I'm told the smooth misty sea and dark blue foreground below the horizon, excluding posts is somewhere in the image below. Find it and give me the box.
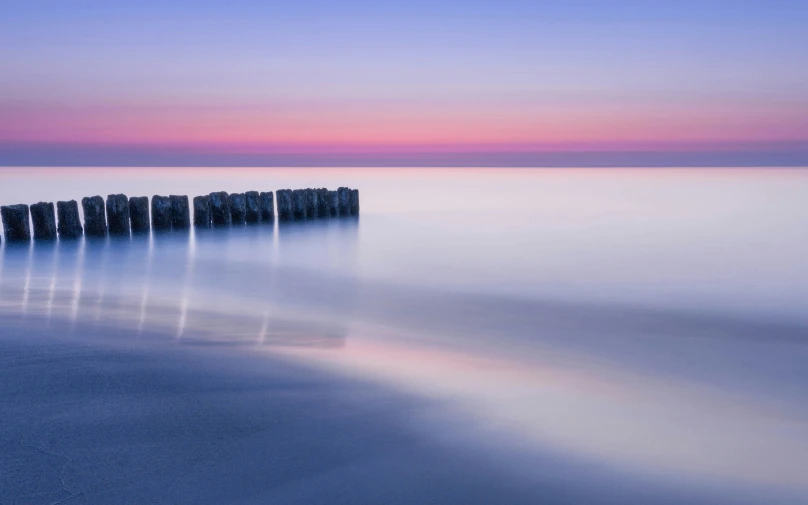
[0,168,808,504]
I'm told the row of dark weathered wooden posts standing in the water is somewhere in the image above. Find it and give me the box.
[0,187,359,242]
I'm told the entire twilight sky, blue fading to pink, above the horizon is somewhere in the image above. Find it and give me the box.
[0,0,808,166]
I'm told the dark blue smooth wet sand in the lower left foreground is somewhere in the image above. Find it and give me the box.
[0,319,804,505]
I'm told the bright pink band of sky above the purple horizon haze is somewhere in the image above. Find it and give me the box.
[0,102,808,152]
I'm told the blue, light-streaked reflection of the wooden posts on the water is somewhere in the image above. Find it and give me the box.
[0,223,356,347]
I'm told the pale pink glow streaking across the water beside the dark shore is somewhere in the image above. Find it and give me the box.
[272,328,808,492]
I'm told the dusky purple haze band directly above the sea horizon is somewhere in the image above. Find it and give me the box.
[0,140,808,168]
